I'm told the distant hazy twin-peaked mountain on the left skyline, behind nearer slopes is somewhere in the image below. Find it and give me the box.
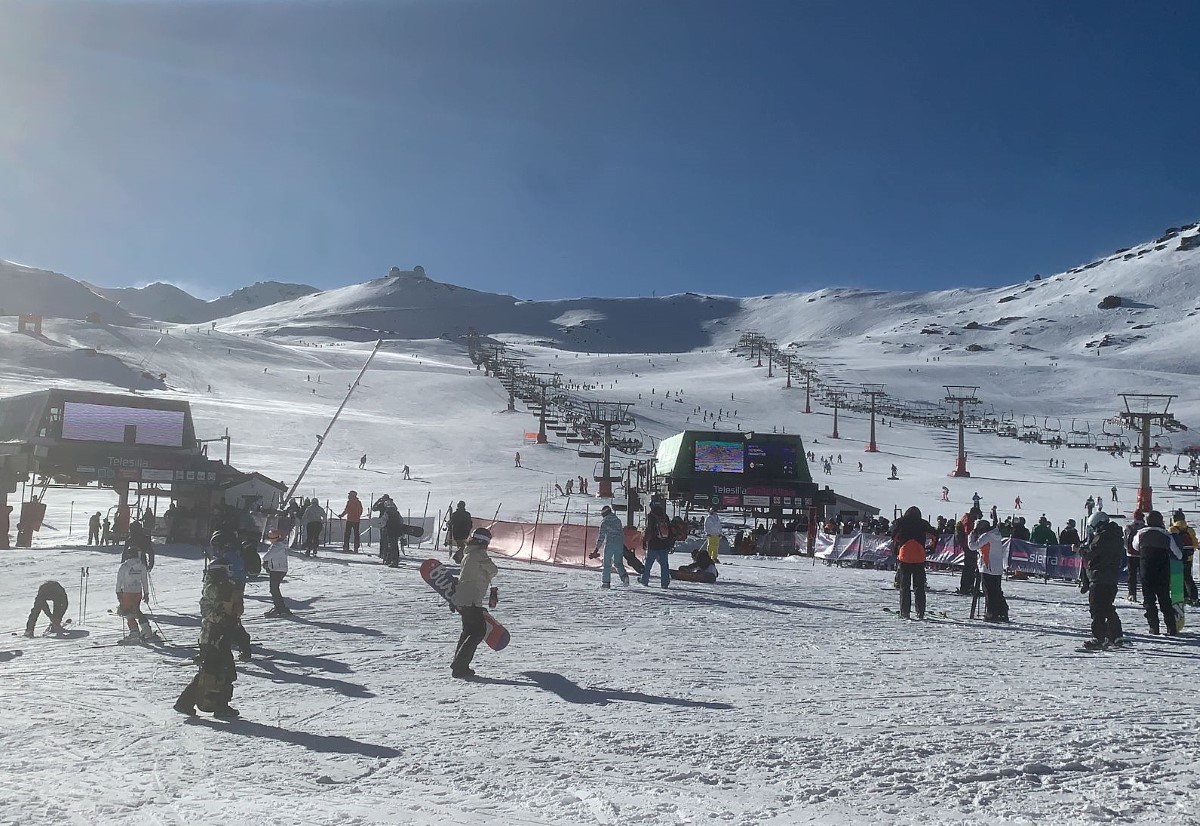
[86,281,317,324]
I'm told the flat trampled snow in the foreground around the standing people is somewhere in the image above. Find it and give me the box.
[0,537,1200,825]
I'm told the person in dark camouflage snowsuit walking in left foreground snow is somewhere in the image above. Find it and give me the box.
[174,558,242,718]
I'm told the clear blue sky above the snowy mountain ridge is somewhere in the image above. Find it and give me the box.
[0,0,1200,298]
